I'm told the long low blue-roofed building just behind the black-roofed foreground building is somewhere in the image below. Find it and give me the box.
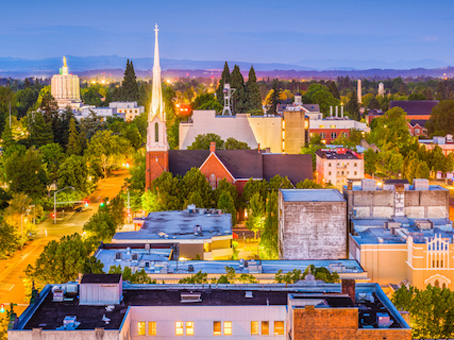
[94,243,369,283]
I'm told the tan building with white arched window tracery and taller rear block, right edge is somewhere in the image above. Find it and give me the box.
[344,179,454,289]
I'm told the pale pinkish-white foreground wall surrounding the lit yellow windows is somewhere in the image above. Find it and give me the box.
[127,301,287,340]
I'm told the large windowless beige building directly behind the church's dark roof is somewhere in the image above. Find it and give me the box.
[180,110,309,154]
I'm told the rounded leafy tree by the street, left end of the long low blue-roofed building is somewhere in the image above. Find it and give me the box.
[27,234,93,283]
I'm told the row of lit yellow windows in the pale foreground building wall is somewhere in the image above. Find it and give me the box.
[137,321,284,336]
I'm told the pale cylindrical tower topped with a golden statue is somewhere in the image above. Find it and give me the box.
[51,57,82,110]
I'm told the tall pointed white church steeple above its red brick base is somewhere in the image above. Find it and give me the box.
[147,24,169,152]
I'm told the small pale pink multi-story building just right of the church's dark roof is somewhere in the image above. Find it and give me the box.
[315,148,364,187]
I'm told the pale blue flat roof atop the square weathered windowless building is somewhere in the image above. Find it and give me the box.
[280,189,345,202]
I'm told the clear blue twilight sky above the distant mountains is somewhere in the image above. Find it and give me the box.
[0,0,454,65]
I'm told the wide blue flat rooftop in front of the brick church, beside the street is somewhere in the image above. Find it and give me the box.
[113,209,232,242]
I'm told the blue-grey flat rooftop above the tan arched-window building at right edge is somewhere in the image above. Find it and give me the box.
[352,218,454,244]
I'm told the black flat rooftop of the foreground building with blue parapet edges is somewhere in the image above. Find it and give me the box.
[13,282,408,331]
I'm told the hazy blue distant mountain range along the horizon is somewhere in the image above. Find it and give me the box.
[0,55,454,79]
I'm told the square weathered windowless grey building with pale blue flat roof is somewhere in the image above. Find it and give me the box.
[278,189,347,260]
